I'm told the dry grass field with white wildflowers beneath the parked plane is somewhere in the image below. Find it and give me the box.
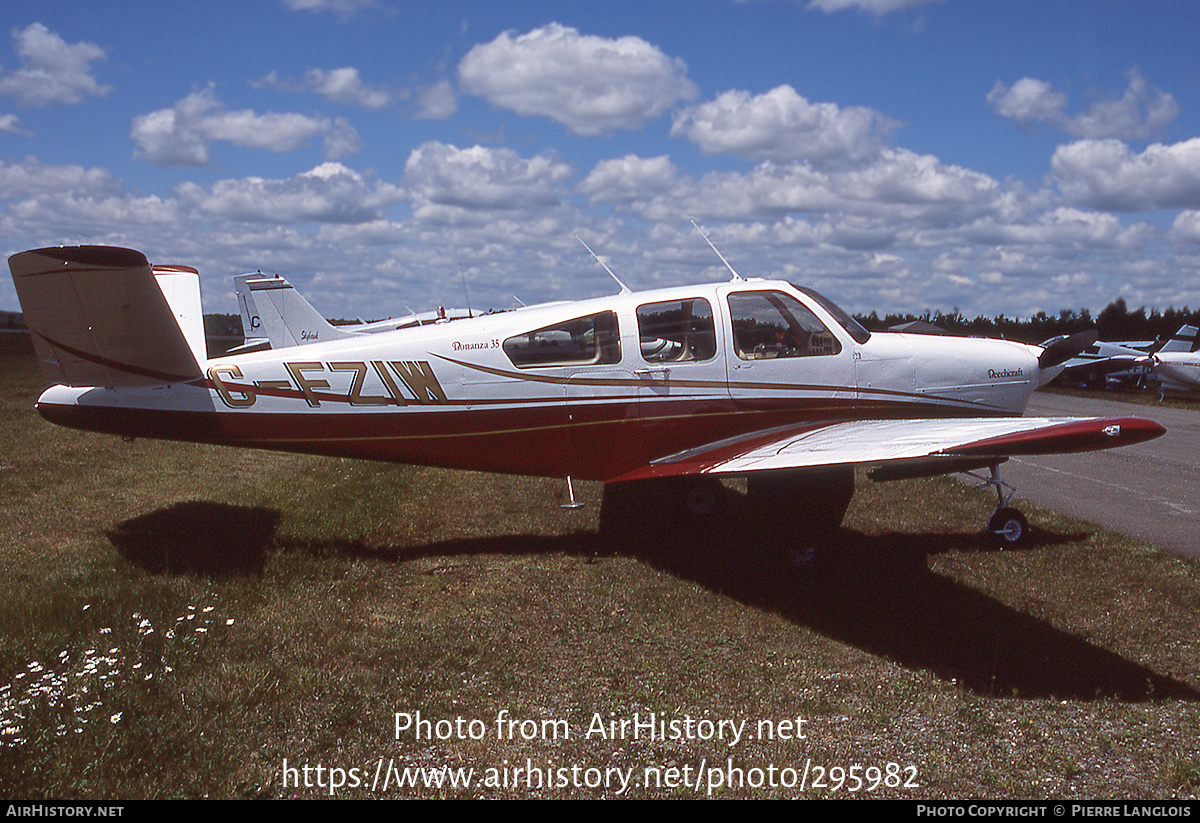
[0,336,1200,799]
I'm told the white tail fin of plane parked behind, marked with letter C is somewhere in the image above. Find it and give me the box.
[233,274,353,350]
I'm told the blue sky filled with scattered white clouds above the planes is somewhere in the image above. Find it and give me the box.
[0,0,1200,319]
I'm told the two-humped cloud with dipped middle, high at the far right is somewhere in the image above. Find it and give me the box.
[988,70,1180,139]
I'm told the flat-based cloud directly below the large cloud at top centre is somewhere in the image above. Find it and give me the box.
[404,143,572,214]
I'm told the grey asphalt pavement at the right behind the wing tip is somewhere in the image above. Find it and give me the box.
[1001,392,1200,557]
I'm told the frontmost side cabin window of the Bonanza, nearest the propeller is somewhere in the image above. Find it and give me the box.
[728,292,841,360]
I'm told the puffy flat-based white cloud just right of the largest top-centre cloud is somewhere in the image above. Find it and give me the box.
[671,85,899,162]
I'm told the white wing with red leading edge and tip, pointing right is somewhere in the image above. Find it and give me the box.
[612,417,1166,481]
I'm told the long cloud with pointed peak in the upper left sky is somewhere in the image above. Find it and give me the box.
[130,84,361,166]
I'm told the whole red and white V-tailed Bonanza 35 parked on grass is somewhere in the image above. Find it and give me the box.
[8,246,1164,551]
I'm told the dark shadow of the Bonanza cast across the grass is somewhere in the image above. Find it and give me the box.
[108,501,1200,702]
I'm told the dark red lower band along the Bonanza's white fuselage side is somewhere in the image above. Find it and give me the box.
[38,398,902,480]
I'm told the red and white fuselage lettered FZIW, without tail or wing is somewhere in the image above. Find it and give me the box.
[38,281,1044,480]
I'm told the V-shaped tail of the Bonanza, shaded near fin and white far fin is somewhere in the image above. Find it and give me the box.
[8,246,205,388]
